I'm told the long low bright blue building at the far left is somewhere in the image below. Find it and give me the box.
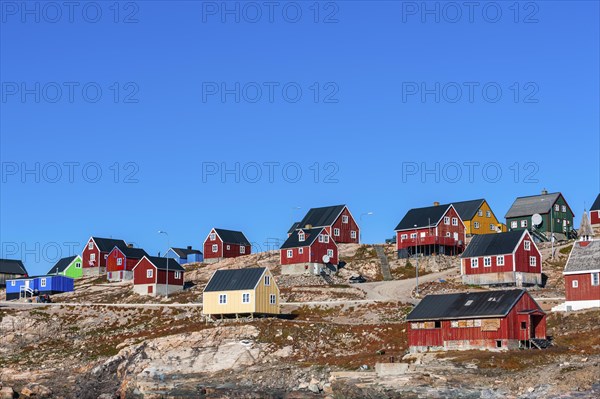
[6,275,75,301]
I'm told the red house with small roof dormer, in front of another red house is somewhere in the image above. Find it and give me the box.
[279,227,338,274]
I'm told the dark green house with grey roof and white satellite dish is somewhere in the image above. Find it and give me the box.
[505,190,575,241]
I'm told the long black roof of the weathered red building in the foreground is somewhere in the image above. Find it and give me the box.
[406,290,526,321]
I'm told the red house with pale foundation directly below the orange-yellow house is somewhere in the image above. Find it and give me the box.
[460,230,542,287]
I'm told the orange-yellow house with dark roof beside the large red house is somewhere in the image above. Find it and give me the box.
[452,198,506,236]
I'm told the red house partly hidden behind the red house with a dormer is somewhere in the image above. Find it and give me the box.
[288,205,360,244]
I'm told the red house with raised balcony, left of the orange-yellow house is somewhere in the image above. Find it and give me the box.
[395,202,466,259]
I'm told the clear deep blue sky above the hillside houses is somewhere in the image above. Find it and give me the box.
[0,1,600,274]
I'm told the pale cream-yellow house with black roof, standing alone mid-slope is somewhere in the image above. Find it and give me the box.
[202,267,280,316]
